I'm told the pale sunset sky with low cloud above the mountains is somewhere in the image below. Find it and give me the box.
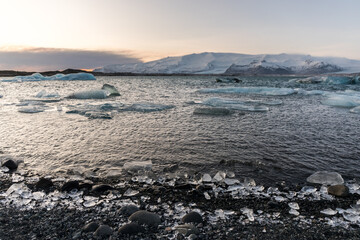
[0,0,360,71]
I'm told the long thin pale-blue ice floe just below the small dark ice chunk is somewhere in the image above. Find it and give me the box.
[198,87,295,96]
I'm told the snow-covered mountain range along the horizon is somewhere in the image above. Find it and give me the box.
[94,53,360,75]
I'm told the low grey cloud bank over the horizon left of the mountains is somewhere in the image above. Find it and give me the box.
[0,48,141,71]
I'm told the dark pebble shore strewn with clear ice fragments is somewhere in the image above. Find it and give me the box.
[0,168,360,240]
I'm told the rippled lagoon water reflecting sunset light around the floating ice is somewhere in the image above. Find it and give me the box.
[0,77,360,185]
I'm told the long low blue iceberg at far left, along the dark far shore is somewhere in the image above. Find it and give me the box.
[1,73,96,82]
